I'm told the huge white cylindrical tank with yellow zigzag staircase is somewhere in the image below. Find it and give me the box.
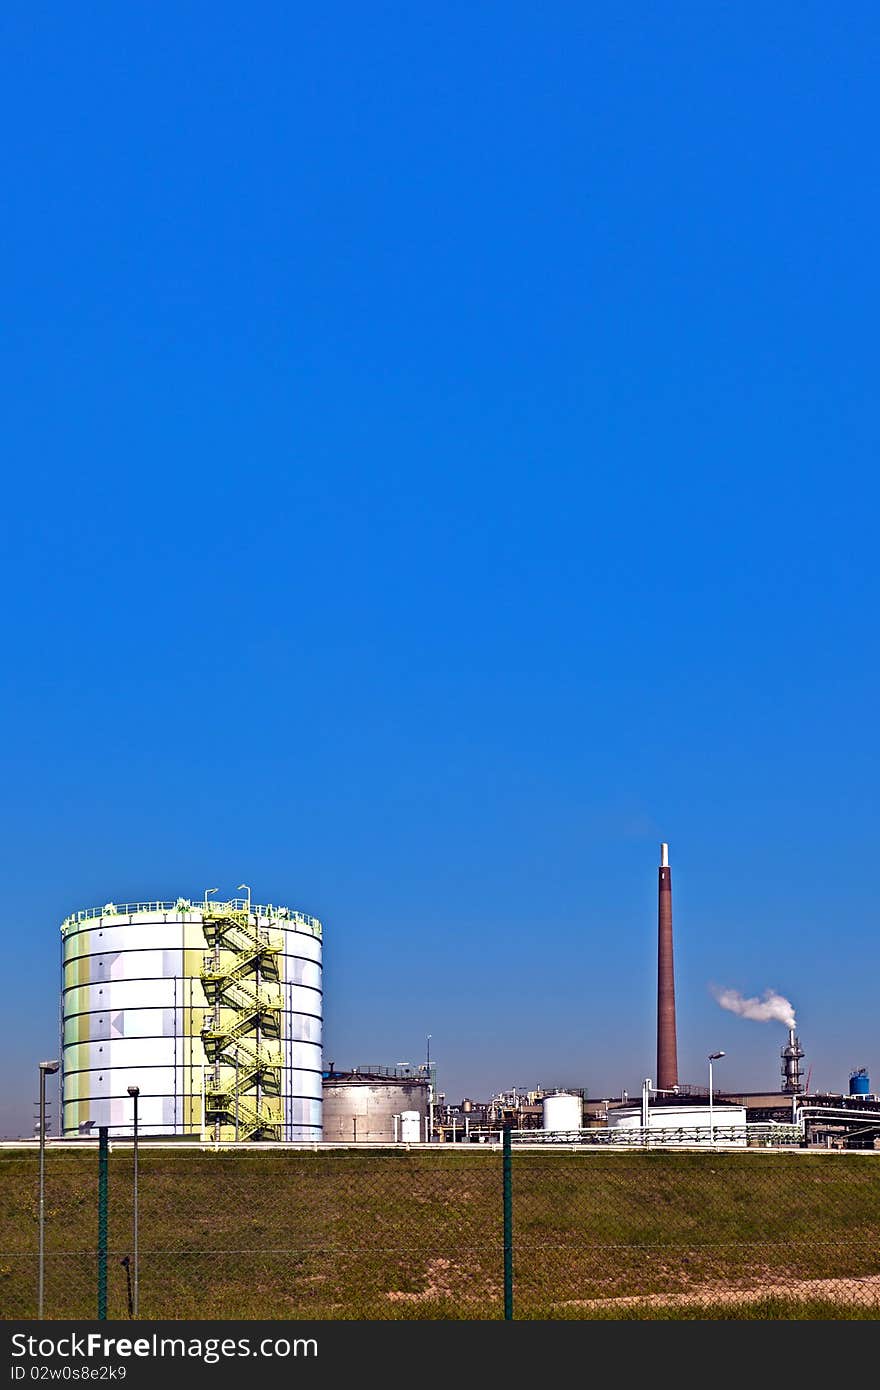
[61,898,323,1141]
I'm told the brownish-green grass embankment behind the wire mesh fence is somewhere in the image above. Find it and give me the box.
[0,1145,880,1319]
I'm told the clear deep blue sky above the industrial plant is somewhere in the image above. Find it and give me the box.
[0,0,880,1134]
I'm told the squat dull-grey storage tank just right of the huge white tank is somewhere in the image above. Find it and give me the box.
[324,1063,430,1144]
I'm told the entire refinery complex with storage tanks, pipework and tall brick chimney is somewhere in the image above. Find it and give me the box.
[61,844,880,1148]
